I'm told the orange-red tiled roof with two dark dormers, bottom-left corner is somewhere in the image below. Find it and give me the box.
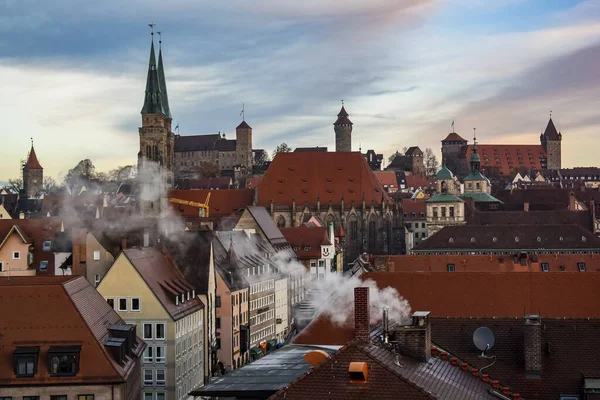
[0,276,145,386]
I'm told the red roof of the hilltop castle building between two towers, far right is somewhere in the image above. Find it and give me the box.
[467,143,546,175]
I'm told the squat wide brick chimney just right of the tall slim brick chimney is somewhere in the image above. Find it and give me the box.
[391,311,431,361]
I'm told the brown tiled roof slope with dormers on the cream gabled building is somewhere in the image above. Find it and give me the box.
[122,247,204,321]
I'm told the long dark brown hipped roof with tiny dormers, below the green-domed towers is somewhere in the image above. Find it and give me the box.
[413,224,600,253]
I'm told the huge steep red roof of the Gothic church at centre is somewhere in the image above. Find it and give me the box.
[258,152,391,207]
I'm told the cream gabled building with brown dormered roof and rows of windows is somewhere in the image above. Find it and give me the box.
[98,247,204,400]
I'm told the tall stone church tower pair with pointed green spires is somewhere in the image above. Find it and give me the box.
[138,32,175,216]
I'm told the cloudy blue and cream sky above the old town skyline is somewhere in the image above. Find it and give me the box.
[0,0,600,180]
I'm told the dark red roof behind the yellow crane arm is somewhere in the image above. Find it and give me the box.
[169,189,254,217]
